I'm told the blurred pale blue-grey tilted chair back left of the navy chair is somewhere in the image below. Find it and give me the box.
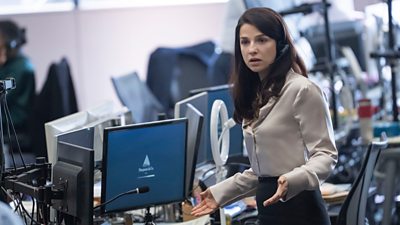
[111,72,164,123]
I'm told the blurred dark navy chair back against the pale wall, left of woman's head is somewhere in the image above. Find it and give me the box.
[146,41,233,117]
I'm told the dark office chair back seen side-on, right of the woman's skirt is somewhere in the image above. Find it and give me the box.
[336,133,387,225]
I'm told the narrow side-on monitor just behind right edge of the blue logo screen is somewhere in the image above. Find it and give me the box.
[185,103,204,197]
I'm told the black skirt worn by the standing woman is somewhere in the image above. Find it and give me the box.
[256,177,331,225]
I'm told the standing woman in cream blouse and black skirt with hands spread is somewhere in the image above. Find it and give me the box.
[192,8,337,225]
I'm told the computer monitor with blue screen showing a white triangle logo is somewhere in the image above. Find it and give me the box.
[101,118,187,213]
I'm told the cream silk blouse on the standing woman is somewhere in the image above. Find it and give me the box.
[210,71,338,206]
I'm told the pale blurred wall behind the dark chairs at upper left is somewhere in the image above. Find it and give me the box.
[0,3,225,109]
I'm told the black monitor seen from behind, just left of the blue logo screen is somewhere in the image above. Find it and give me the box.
[52,141,94,225]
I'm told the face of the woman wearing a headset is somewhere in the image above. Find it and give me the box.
[239,23,276,80]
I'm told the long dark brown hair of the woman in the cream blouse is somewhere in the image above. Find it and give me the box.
[231,8,307,123]
